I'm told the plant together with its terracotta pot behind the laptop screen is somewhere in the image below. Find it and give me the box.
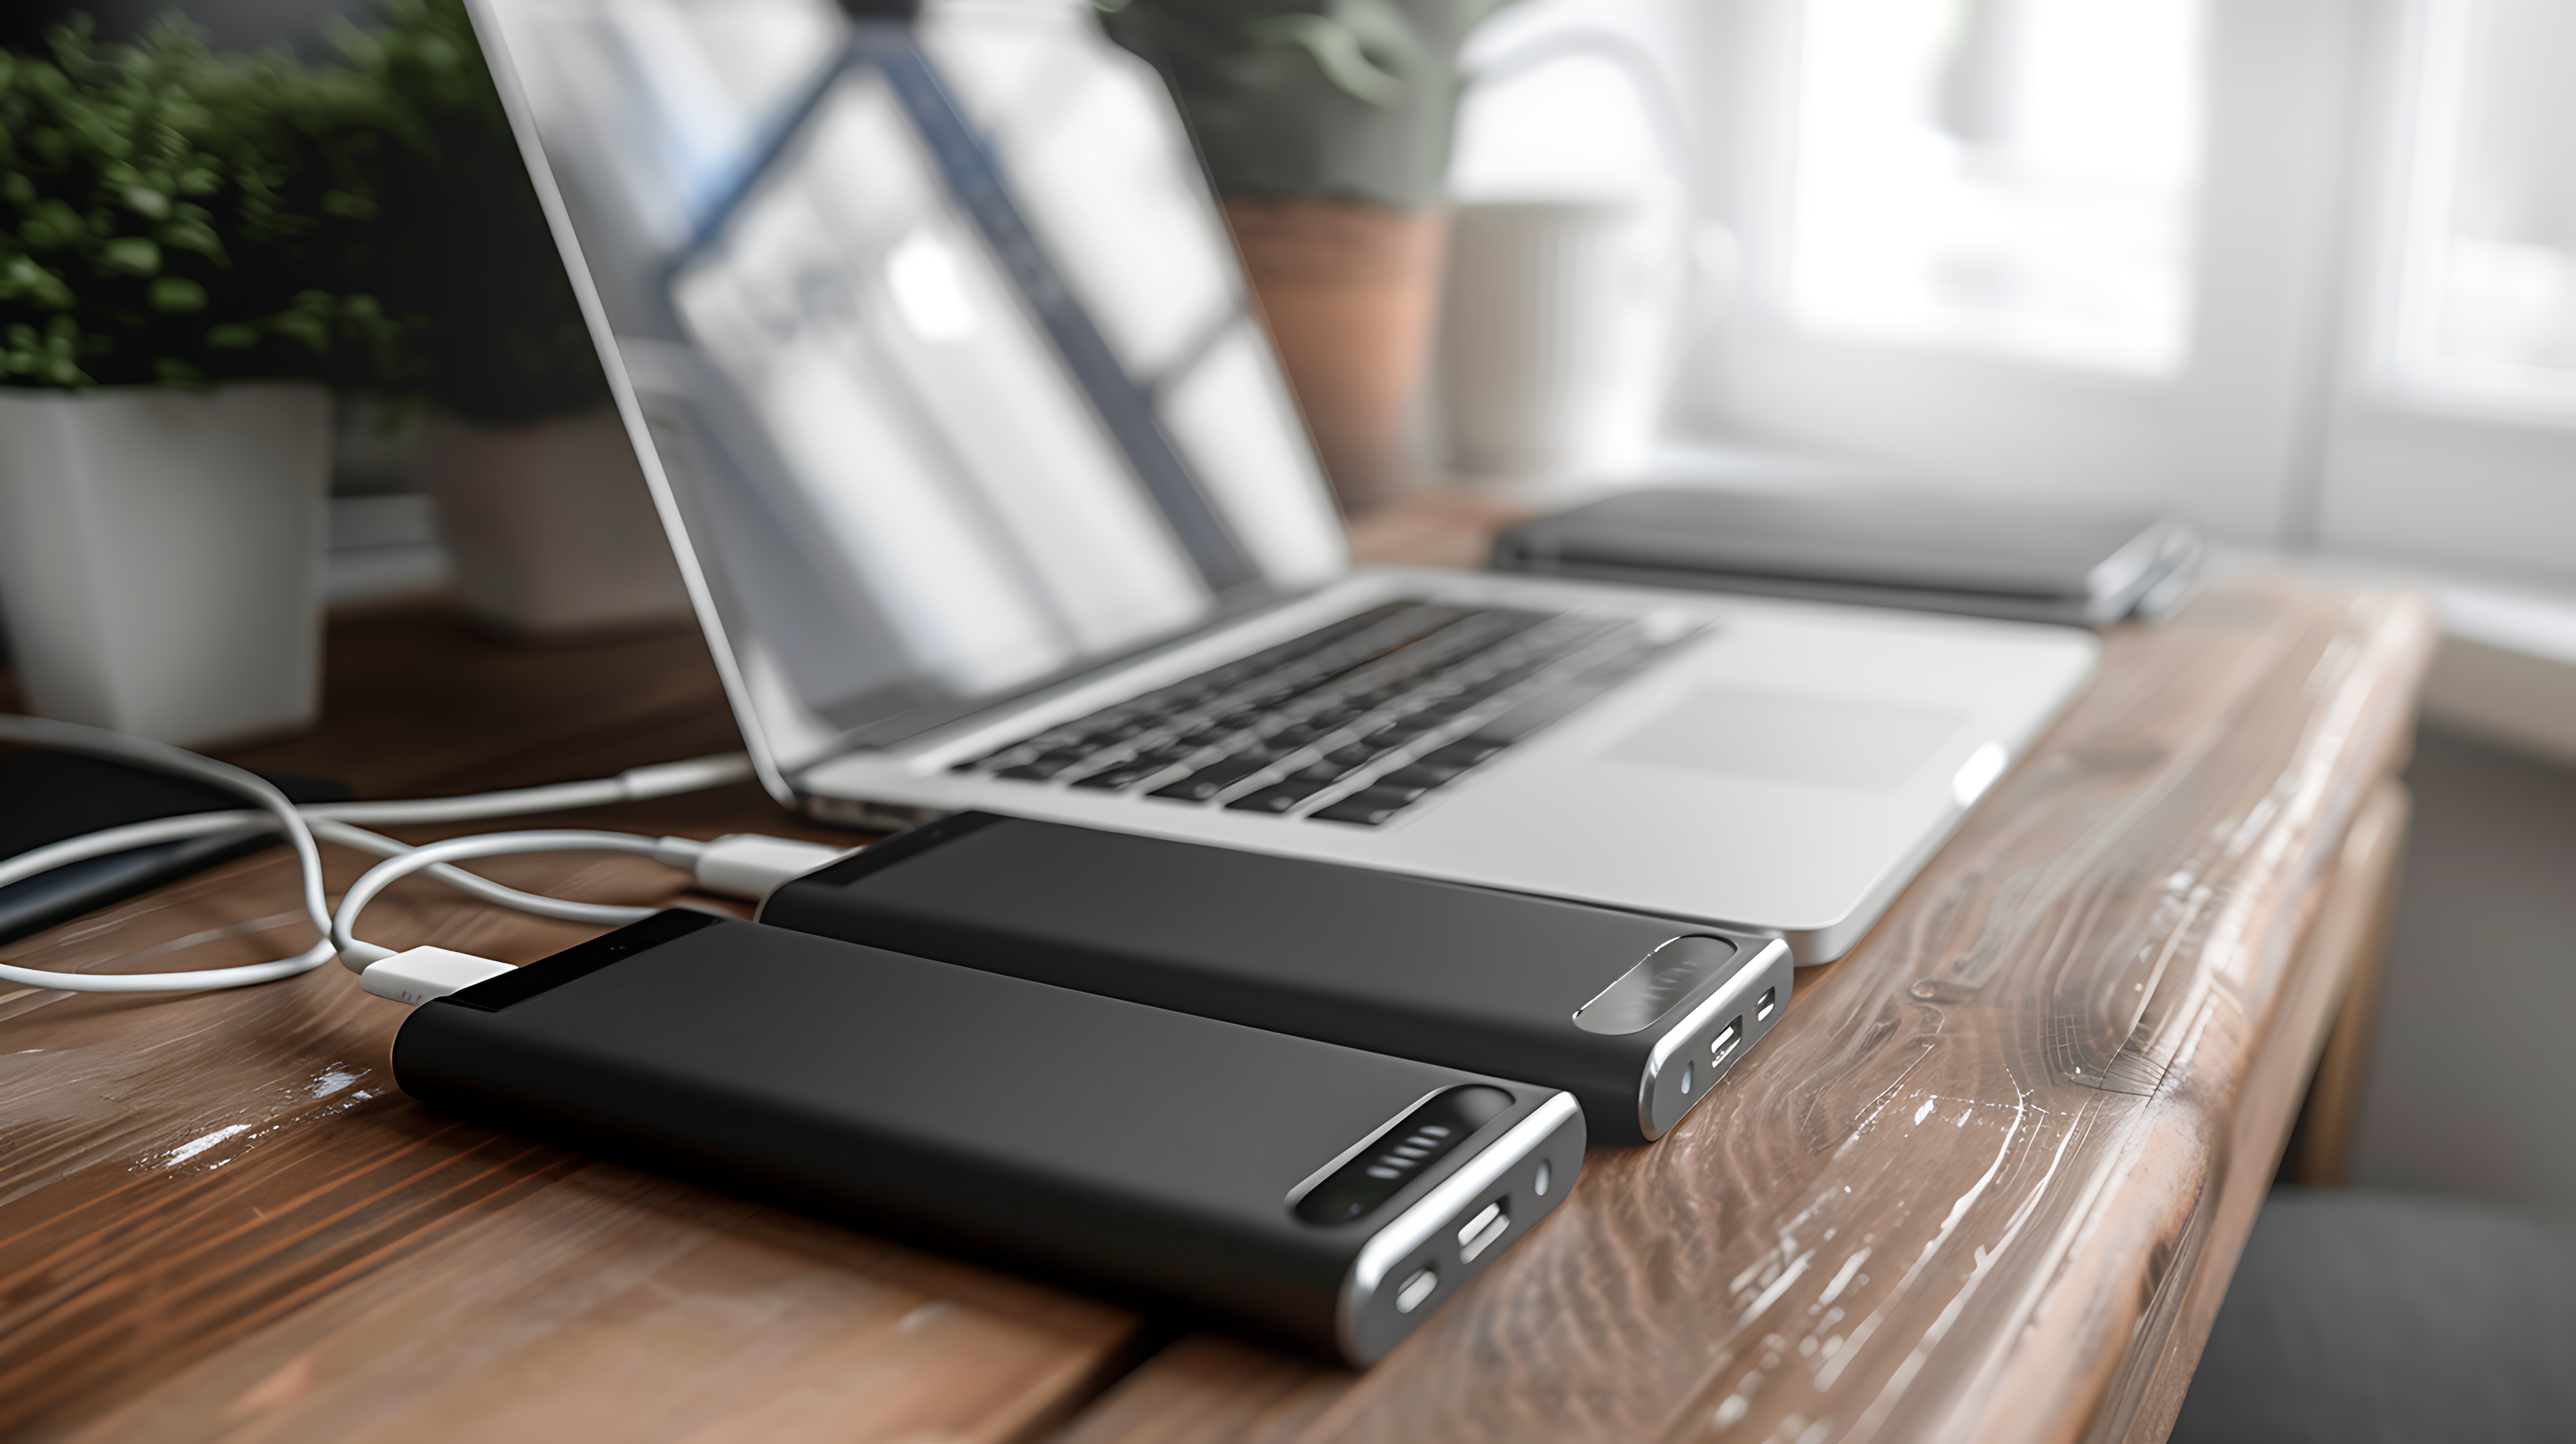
[1097,0,1507,511]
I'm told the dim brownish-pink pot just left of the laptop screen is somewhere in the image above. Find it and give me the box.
[420,407,688,637]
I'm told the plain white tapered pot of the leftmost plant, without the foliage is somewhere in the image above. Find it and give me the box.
[0,382,330,745]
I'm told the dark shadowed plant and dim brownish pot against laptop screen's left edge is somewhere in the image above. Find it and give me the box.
[340,0,688,637]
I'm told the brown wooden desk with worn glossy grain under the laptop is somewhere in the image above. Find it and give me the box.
[0,513,2432,1444]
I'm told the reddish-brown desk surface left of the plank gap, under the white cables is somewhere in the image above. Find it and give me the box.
[0,609,1136,1441]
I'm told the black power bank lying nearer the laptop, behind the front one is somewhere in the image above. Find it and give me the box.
[760,812,1793,1142]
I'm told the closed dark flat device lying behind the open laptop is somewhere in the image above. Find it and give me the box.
[1489,490,2200,626]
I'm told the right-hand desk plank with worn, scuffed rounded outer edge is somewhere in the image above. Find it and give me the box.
[1064,583,2432,1444]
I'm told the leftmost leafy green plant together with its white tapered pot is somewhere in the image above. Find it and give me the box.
[0,23,399,743]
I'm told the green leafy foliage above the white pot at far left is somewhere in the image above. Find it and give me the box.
[0,21,404,387]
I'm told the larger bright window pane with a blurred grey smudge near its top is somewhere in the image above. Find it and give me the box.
[1788,0,2203,376]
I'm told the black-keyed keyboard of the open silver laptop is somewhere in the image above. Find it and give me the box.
[951,601,1675,828]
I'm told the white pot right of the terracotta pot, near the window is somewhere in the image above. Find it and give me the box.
[1440,199,1687,477]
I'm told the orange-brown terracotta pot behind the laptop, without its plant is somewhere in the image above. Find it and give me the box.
[1226,196,1448,516]
